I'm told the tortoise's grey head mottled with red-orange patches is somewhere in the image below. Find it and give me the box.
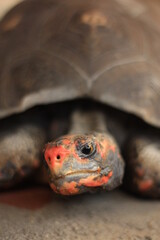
[44,133,124,195]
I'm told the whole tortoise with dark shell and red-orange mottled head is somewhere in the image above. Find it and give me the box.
[0,0,160,198]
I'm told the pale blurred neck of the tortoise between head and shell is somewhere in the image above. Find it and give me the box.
[69,110,107,134]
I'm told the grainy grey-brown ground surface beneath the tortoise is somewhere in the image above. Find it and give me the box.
[0,189,160,240]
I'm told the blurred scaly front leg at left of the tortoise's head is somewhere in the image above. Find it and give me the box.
[0,119,46,188]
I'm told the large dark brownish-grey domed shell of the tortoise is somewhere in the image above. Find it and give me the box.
[0,0,160,126]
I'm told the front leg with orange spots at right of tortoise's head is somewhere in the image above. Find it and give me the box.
[124,133,160,198]
